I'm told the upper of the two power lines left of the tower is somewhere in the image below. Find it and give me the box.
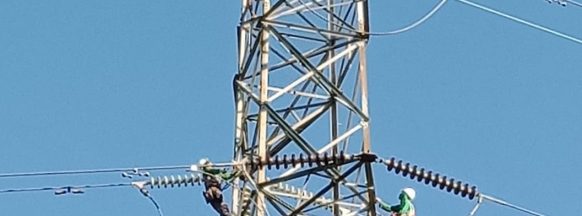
[0,165,190,178]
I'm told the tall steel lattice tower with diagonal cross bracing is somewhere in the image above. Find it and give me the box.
[232,0,376,216]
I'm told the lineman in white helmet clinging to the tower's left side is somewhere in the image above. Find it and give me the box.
[199,158,238,216]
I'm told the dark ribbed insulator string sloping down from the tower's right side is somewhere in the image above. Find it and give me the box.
[380,157,479,200]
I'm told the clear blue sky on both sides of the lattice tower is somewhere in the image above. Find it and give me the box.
[0,0,582,216]
